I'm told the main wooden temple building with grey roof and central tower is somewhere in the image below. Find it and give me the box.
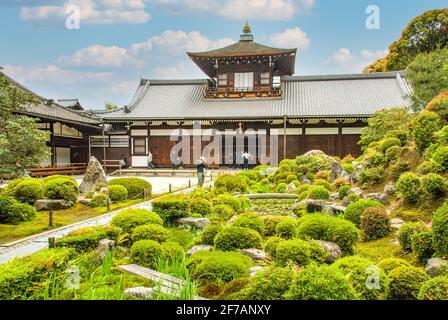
[99,24,412,167]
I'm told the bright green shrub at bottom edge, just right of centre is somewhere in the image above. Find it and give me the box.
[239,268,294,300]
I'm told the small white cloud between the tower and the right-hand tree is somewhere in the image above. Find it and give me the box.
[325,48,388,72]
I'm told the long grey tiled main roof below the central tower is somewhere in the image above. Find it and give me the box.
[101,72,411,122]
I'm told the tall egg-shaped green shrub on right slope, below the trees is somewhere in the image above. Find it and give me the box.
[411,111,442,151]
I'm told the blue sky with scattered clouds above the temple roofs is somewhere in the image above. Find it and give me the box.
[0,0,448,109]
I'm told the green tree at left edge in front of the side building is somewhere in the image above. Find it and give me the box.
[0,72,50,173]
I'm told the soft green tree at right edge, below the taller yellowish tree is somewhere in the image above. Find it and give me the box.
[407,48,448,111]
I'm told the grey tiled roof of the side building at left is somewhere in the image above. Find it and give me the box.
[2,73,101,127]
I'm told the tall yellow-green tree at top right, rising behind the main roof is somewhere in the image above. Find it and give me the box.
[364,9,448,73]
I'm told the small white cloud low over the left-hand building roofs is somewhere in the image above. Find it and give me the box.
[58,45,144,68]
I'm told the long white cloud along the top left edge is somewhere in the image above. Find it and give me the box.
[20,0,150,25]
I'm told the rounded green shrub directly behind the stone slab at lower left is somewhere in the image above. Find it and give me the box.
[130,240,163,269]
